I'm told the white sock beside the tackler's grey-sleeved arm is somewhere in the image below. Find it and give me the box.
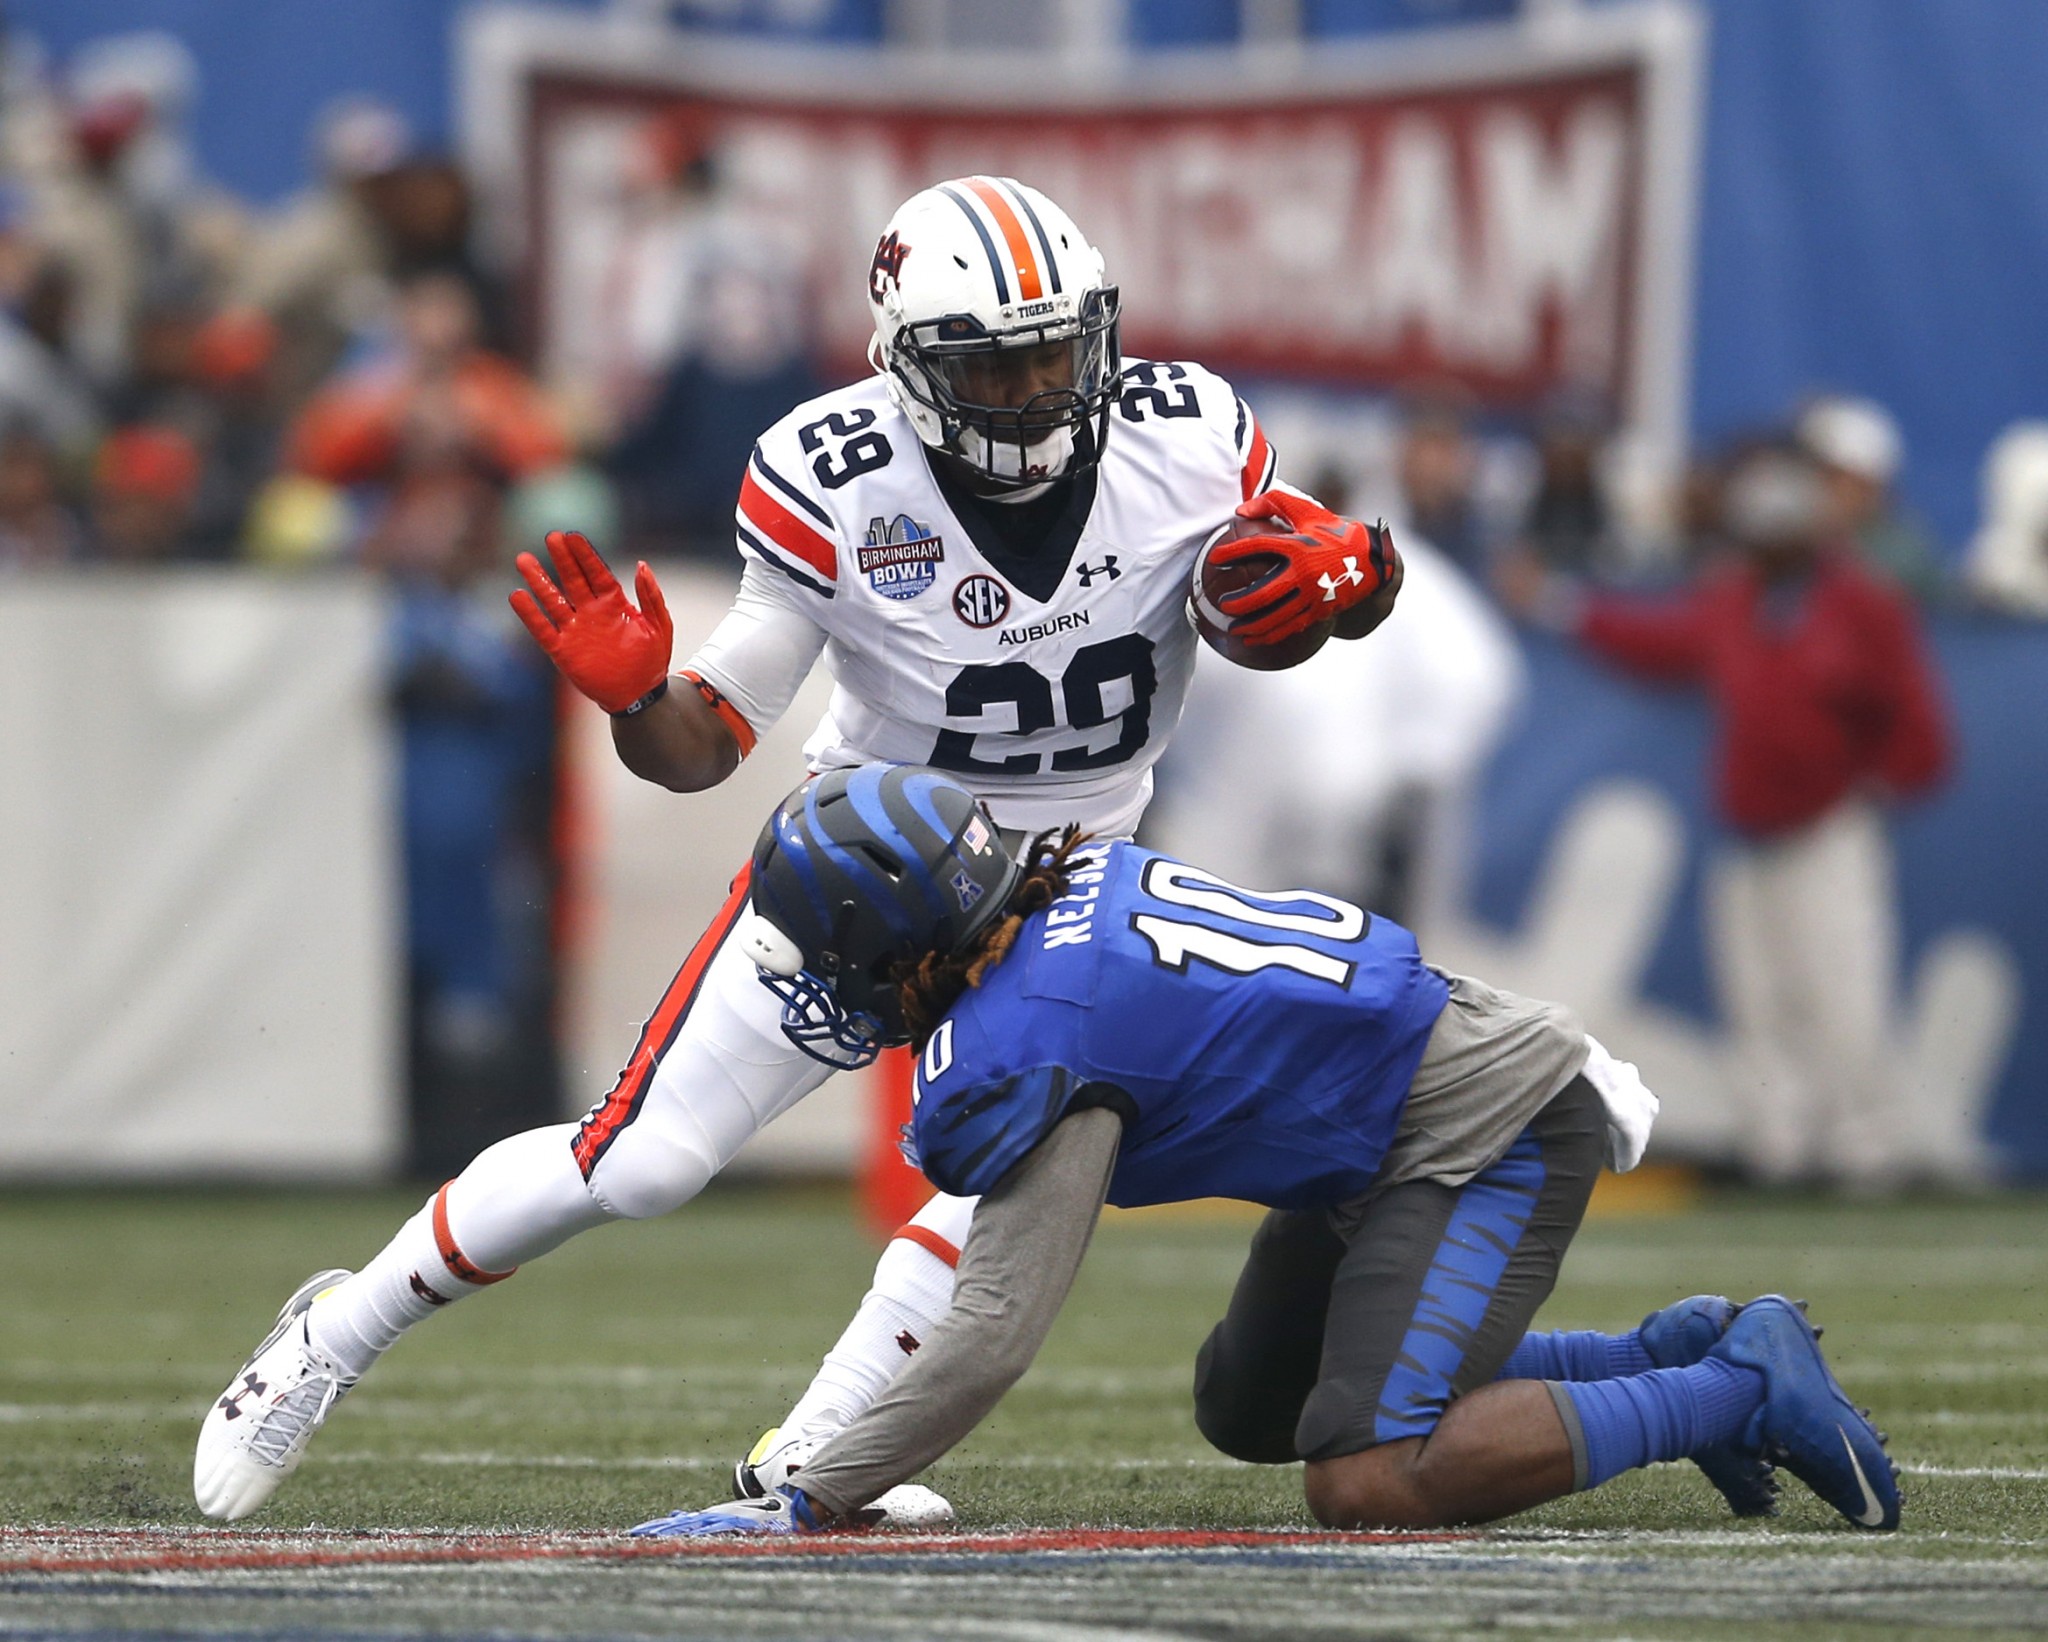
[782,1198,973,1441]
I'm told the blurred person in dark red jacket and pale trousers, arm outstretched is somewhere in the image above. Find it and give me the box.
[1503,442,1950,1187]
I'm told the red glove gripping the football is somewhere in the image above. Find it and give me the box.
[1208,489,1397,645]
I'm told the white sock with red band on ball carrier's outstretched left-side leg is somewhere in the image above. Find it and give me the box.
[305,1124,610,1378]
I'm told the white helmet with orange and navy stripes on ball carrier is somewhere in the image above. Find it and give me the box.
[868,176,1122,485]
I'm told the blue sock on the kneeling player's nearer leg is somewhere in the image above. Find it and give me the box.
[1550,1357,1763,1488]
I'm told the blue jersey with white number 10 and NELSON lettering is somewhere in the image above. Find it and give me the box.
[909,844,1450,1208]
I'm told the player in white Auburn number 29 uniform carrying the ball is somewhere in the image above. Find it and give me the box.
[193,176,1399,1523]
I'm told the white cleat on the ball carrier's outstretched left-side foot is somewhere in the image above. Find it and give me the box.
[193,1269,354,1523]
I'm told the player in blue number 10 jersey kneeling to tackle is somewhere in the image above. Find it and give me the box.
[635,764,1901,1533]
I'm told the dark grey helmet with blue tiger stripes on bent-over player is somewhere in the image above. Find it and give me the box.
[737,764,1020,1067]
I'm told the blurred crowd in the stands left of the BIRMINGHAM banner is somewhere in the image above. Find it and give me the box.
[0,35,575,586]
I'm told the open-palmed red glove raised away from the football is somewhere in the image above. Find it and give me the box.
[512,530,676,712]
